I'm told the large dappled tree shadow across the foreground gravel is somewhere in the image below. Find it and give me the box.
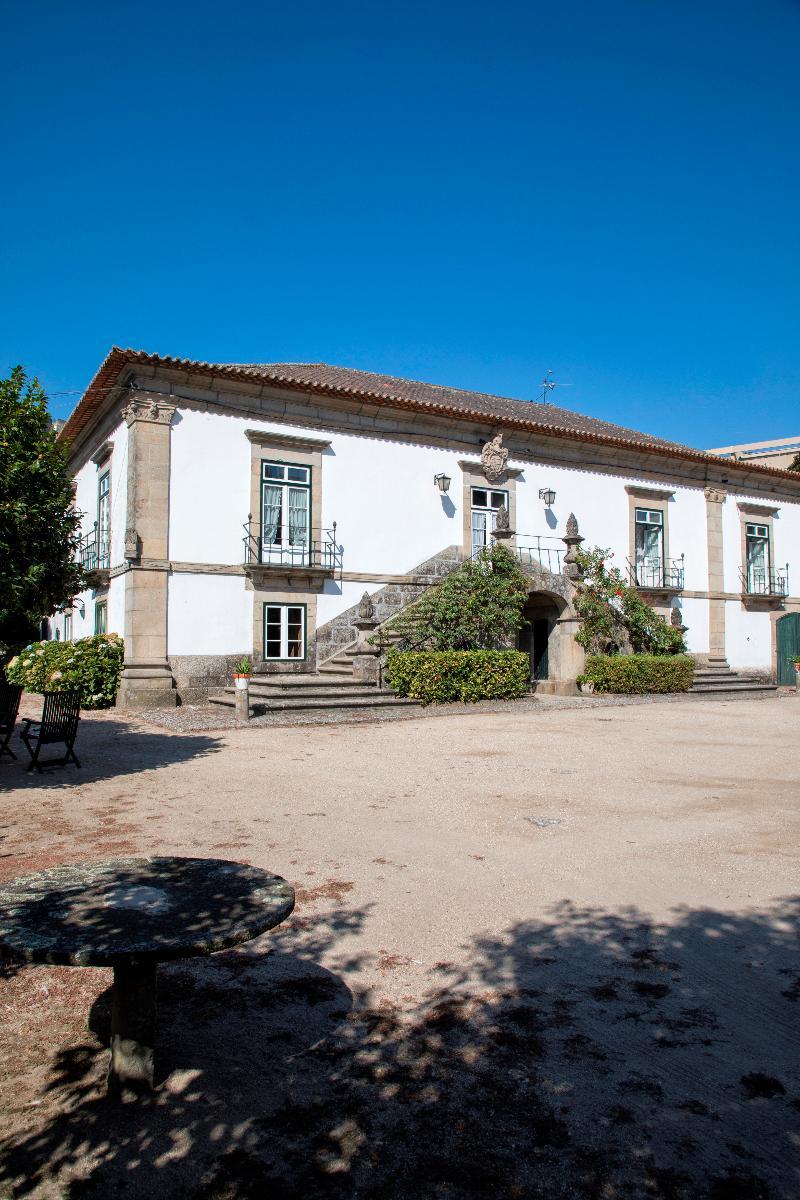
[0,899,800,1200]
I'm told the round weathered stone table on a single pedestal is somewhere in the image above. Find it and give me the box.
[0,858,294,1099]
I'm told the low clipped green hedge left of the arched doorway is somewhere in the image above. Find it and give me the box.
[386,650,530,704]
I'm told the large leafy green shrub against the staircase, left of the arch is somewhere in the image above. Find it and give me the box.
[384,545,530,650]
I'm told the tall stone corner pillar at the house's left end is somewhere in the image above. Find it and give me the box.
[116,392,178,708]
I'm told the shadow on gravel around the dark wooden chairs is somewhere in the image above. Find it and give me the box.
[0,714,219,791]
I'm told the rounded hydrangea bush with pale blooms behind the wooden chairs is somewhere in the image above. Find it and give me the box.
[5,634,124,708]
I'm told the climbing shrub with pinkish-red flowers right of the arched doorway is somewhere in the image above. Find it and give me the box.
[575,547,686,654]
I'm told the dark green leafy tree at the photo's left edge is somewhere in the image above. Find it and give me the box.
[0,367,84,652]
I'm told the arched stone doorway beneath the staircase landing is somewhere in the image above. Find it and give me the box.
[517,592,584,696]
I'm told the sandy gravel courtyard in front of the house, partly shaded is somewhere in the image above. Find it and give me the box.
[0,695,800,1200]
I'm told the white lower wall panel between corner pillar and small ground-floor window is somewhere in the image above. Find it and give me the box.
[167,572,253,655]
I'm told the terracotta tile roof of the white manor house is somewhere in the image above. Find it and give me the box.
[59,346,800,492]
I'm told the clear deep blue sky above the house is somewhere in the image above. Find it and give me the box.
[0,0,800,445]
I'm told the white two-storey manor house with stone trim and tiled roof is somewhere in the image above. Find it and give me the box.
[52,348,800,707]
